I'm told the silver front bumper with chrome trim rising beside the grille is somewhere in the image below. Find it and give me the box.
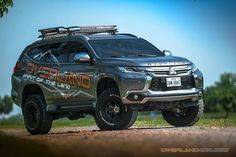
[122,69,203,104]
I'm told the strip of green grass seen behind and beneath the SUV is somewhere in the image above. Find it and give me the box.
[0,112,236,129]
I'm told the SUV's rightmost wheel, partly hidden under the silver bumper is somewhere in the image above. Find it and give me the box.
[161,100,204,127]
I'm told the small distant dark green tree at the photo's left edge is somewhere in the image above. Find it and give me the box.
[0,95,13,115]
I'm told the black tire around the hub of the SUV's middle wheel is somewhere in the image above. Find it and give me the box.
[95,88,138,130]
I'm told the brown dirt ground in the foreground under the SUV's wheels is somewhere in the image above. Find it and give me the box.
[1,127,236,157]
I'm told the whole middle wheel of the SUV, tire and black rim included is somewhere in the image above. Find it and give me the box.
[95,89,138,130]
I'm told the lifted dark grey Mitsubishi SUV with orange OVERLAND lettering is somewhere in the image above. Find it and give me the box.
[12,26,203,134]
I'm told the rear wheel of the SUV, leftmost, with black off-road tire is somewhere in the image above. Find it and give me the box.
[23,95,53,135]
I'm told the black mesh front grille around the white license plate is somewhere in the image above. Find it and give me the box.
[149,76,195,91]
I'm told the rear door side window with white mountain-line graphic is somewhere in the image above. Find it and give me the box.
[44,43,67,63]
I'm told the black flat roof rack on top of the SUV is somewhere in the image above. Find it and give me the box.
[38,25,118,39]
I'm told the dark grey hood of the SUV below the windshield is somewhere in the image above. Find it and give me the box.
[98,56,192,67]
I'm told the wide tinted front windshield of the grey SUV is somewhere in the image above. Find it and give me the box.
[89,39,164,58]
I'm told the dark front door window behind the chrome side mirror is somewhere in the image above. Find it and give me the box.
[65,42,89,63]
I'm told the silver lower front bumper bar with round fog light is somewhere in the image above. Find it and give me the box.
[122,88,202,104]
